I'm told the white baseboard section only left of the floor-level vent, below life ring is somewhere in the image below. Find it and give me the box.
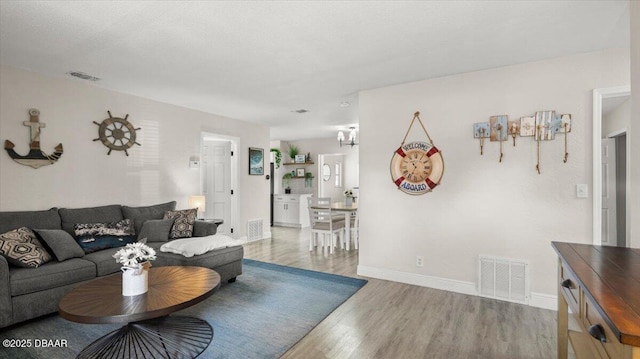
[358,265,478,295]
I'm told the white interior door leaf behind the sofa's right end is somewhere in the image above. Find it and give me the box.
[202,140,231,235]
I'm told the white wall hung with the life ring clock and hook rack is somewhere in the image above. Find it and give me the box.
[358,50,629,307]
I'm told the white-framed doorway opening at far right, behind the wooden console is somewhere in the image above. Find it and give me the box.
[593,86,631,247]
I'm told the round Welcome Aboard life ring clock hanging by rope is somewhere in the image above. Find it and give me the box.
[390,112,444,195]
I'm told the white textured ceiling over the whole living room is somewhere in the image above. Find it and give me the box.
[0,0,629,140]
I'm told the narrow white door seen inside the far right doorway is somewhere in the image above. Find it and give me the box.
[602,138,618,246]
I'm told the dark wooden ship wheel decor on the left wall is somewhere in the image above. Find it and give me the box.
[93,111,141,156]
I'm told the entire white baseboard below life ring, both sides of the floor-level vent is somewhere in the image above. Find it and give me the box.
[358,265,558,310]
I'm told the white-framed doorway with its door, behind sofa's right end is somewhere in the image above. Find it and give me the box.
[200,133,238,237]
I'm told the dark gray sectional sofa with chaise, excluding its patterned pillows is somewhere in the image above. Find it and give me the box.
[0,202,244,328]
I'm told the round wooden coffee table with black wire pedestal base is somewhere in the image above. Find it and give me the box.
[58,267,220,358]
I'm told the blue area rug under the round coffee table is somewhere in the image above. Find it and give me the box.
[0,259,367,359]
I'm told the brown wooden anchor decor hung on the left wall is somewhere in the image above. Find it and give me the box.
[4,108,63,168]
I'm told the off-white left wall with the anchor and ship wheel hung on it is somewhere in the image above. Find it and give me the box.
[0,66,269,237]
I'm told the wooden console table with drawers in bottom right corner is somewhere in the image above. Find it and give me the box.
[552,242,640,359]
